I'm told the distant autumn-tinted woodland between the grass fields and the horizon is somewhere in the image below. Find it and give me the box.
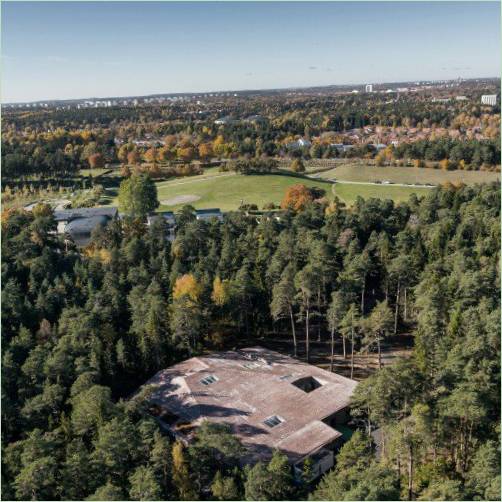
[2,90,500,178]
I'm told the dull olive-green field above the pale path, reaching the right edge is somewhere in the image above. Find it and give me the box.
[319,163,500,185]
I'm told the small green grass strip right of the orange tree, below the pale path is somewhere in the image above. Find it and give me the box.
[333,183,431,205]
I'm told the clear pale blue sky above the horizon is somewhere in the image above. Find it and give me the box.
[1,1,500,103]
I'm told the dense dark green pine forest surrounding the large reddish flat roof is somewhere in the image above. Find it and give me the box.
[2,185,500,500]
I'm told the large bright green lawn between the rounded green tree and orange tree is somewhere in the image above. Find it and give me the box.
[157,173,332,211]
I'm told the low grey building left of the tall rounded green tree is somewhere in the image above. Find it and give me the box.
[54,207,118,247]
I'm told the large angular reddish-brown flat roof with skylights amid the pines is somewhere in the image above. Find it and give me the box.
[146,347,357,462]
